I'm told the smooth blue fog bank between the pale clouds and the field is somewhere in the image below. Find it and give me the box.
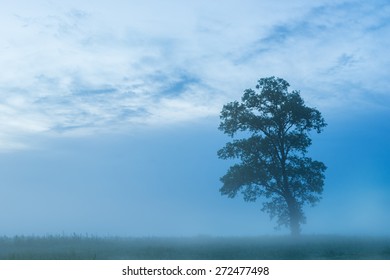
[0,110,390,236]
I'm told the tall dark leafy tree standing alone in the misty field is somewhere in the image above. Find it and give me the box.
[218,77,326,236]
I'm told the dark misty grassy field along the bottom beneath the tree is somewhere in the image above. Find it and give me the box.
[0,235,390,260]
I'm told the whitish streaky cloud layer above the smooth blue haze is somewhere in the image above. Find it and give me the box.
[0,0,390,149]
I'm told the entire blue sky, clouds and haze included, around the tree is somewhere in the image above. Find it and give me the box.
[0,0,390,236]
